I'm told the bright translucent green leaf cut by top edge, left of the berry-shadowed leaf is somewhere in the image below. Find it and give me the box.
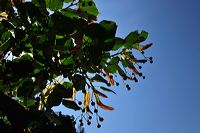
[45,0,63,11]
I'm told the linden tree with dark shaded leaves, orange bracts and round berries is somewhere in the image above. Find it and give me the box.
[0,0,153,133]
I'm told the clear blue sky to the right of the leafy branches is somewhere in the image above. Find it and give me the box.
[60,0,200,133]
